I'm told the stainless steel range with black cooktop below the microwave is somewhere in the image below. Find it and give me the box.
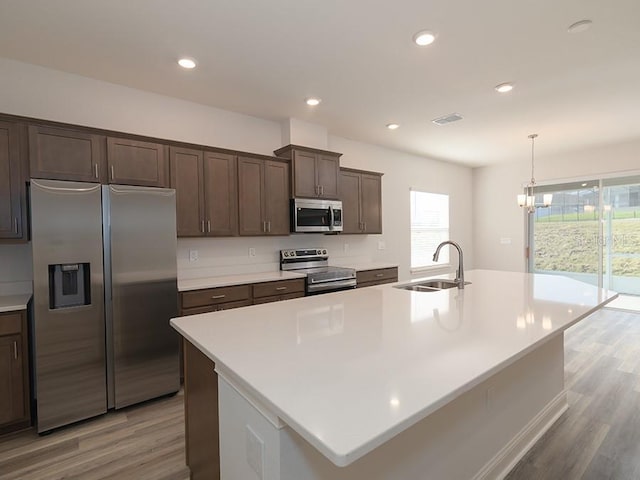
[280,248,356,295]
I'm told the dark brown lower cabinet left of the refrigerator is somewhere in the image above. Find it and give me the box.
[0,311,31,434]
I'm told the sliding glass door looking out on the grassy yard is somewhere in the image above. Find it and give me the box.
[528,176,640,295]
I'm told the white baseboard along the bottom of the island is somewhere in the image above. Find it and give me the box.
[473,390,569,480]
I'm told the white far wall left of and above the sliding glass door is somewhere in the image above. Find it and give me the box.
[473,139,640,271]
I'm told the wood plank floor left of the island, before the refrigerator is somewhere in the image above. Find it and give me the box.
[0,393,189,480]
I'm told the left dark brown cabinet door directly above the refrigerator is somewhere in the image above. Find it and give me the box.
[29,125,105,183]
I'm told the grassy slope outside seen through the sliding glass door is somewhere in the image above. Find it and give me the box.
[534,217,640,277]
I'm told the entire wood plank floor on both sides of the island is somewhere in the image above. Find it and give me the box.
[0,309,640,480]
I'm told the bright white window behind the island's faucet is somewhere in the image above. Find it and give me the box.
[410,190,449,270]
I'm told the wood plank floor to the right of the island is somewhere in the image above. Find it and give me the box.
[507,309,640,480]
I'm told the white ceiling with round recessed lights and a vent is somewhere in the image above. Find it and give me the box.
[0,0,640,166]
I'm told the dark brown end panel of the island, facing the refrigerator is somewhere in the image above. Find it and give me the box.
[183,338,220,480]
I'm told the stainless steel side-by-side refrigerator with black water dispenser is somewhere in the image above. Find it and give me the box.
[30,179,180,432]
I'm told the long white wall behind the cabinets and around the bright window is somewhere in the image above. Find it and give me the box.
[0,59,473,282]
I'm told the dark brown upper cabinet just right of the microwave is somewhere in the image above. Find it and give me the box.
[340,168,382,234]
